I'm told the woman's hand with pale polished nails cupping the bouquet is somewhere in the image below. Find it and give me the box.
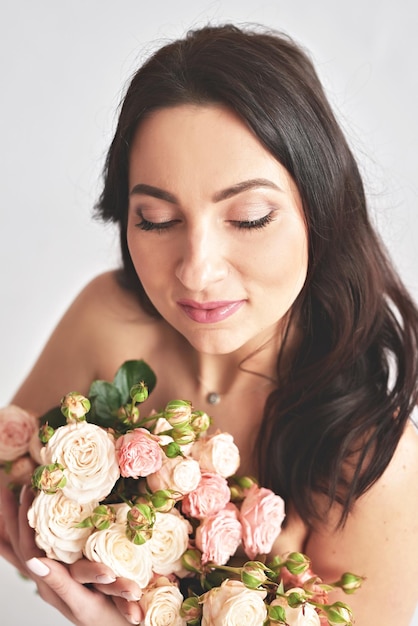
[0,488,142,626]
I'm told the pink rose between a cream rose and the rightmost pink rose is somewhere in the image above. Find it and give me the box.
[196,503,242,565]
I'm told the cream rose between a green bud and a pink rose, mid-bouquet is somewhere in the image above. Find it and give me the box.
[149,509,192,576]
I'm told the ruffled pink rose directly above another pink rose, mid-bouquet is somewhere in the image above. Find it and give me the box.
[181,472,231,519]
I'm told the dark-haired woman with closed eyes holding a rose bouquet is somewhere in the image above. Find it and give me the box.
[2,26,418,626]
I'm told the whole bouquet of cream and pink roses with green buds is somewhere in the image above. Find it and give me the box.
[0,361,361,626]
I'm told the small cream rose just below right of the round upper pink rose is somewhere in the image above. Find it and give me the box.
[147,456,201,496]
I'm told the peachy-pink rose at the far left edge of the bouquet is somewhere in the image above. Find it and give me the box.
[0,404,39,463]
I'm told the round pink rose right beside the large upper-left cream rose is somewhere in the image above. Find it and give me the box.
[116,428,164,478]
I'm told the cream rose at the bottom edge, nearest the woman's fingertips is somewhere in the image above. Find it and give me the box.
[139,584,186,626]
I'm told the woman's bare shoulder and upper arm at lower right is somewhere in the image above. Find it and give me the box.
[306,422,418,626]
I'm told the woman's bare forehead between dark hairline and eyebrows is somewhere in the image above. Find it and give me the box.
[130,104,294,199]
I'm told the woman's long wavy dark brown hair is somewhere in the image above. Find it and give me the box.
[96,25,418,524]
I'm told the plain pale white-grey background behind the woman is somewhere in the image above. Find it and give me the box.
[0,0,418,626]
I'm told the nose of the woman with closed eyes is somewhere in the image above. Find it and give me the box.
[176,225,228,292]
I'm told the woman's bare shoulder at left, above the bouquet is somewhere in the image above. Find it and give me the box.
[13,272,159,413]
